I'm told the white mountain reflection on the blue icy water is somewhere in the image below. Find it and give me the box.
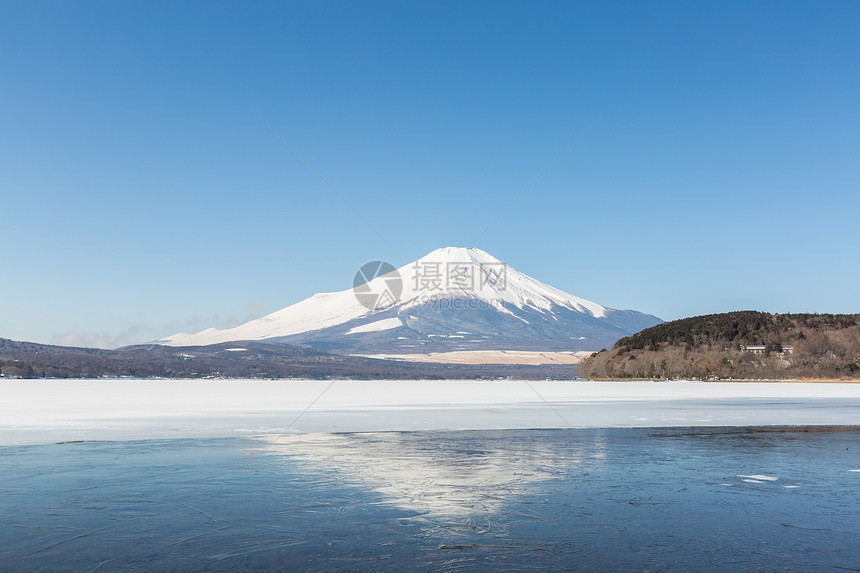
[252,432,605,523]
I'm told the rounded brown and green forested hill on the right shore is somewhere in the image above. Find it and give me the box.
[580,311,860,379]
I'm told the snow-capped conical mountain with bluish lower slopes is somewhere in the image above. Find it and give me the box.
[158,247,662,354]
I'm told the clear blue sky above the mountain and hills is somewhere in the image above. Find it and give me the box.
[0,0,860,346]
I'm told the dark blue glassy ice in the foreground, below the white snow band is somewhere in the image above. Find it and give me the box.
[0,428,860,571]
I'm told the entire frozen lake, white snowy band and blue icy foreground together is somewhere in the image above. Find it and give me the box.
[5,380,860,571]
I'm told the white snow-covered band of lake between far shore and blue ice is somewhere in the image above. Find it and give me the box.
[0,380,860,445]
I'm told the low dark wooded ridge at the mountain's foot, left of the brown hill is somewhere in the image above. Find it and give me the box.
[0,338,577,380]
